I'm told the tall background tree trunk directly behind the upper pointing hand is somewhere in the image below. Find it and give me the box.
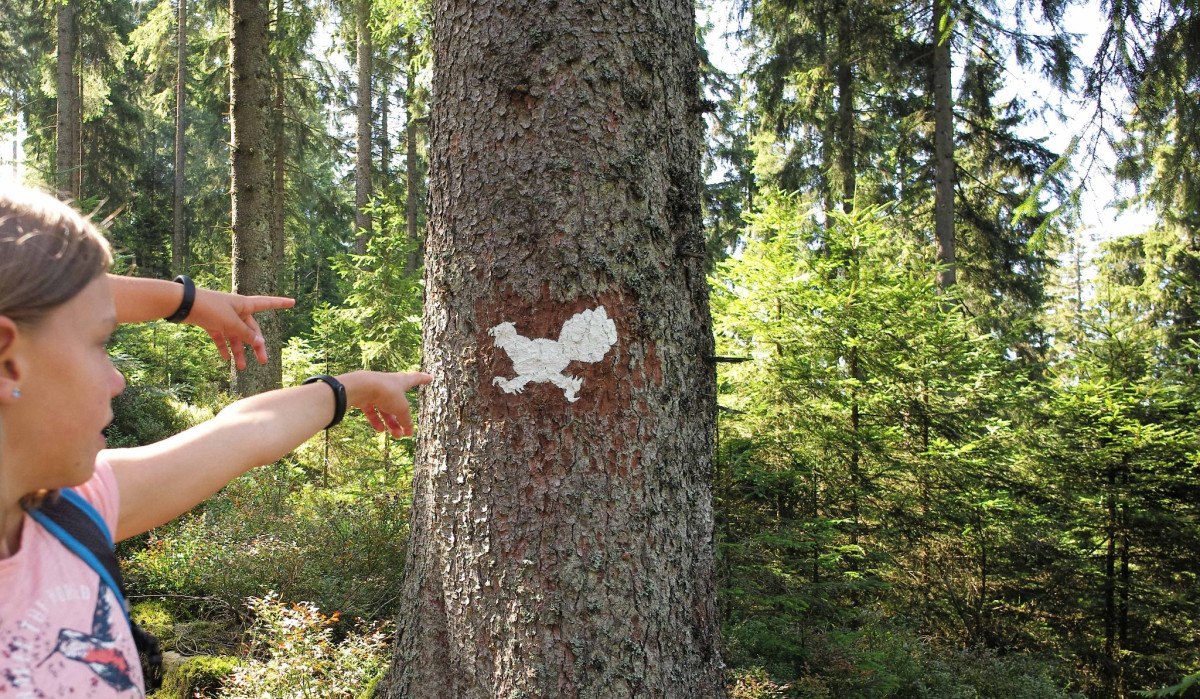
[229,0,282,395]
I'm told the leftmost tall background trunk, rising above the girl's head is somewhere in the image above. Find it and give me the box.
[54,0,83,199]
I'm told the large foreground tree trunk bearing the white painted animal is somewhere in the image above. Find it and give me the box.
[382,0,725,699]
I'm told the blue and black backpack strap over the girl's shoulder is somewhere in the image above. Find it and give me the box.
[29,489,128,619]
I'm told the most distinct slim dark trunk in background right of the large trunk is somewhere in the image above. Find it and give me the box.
[932,0,956,289]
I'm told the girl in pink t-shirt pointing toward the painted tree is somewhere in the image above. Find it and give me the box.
[0,185,430,697]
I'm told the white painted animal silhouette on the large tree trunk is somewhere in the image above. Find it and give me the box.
[488,306,617,402]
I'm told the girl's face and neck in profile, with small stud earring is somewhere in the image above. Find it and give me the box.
[5,275,125,492]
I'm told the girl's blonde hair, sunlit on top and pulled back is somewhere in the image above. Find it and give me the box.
[0,184,113,506]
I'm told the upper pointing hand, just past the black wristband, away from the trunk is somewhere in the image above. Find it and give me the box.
[184,288,296,370]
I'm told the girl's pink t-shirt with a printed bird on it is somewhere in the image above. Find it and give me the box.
[0,461,145,699]
